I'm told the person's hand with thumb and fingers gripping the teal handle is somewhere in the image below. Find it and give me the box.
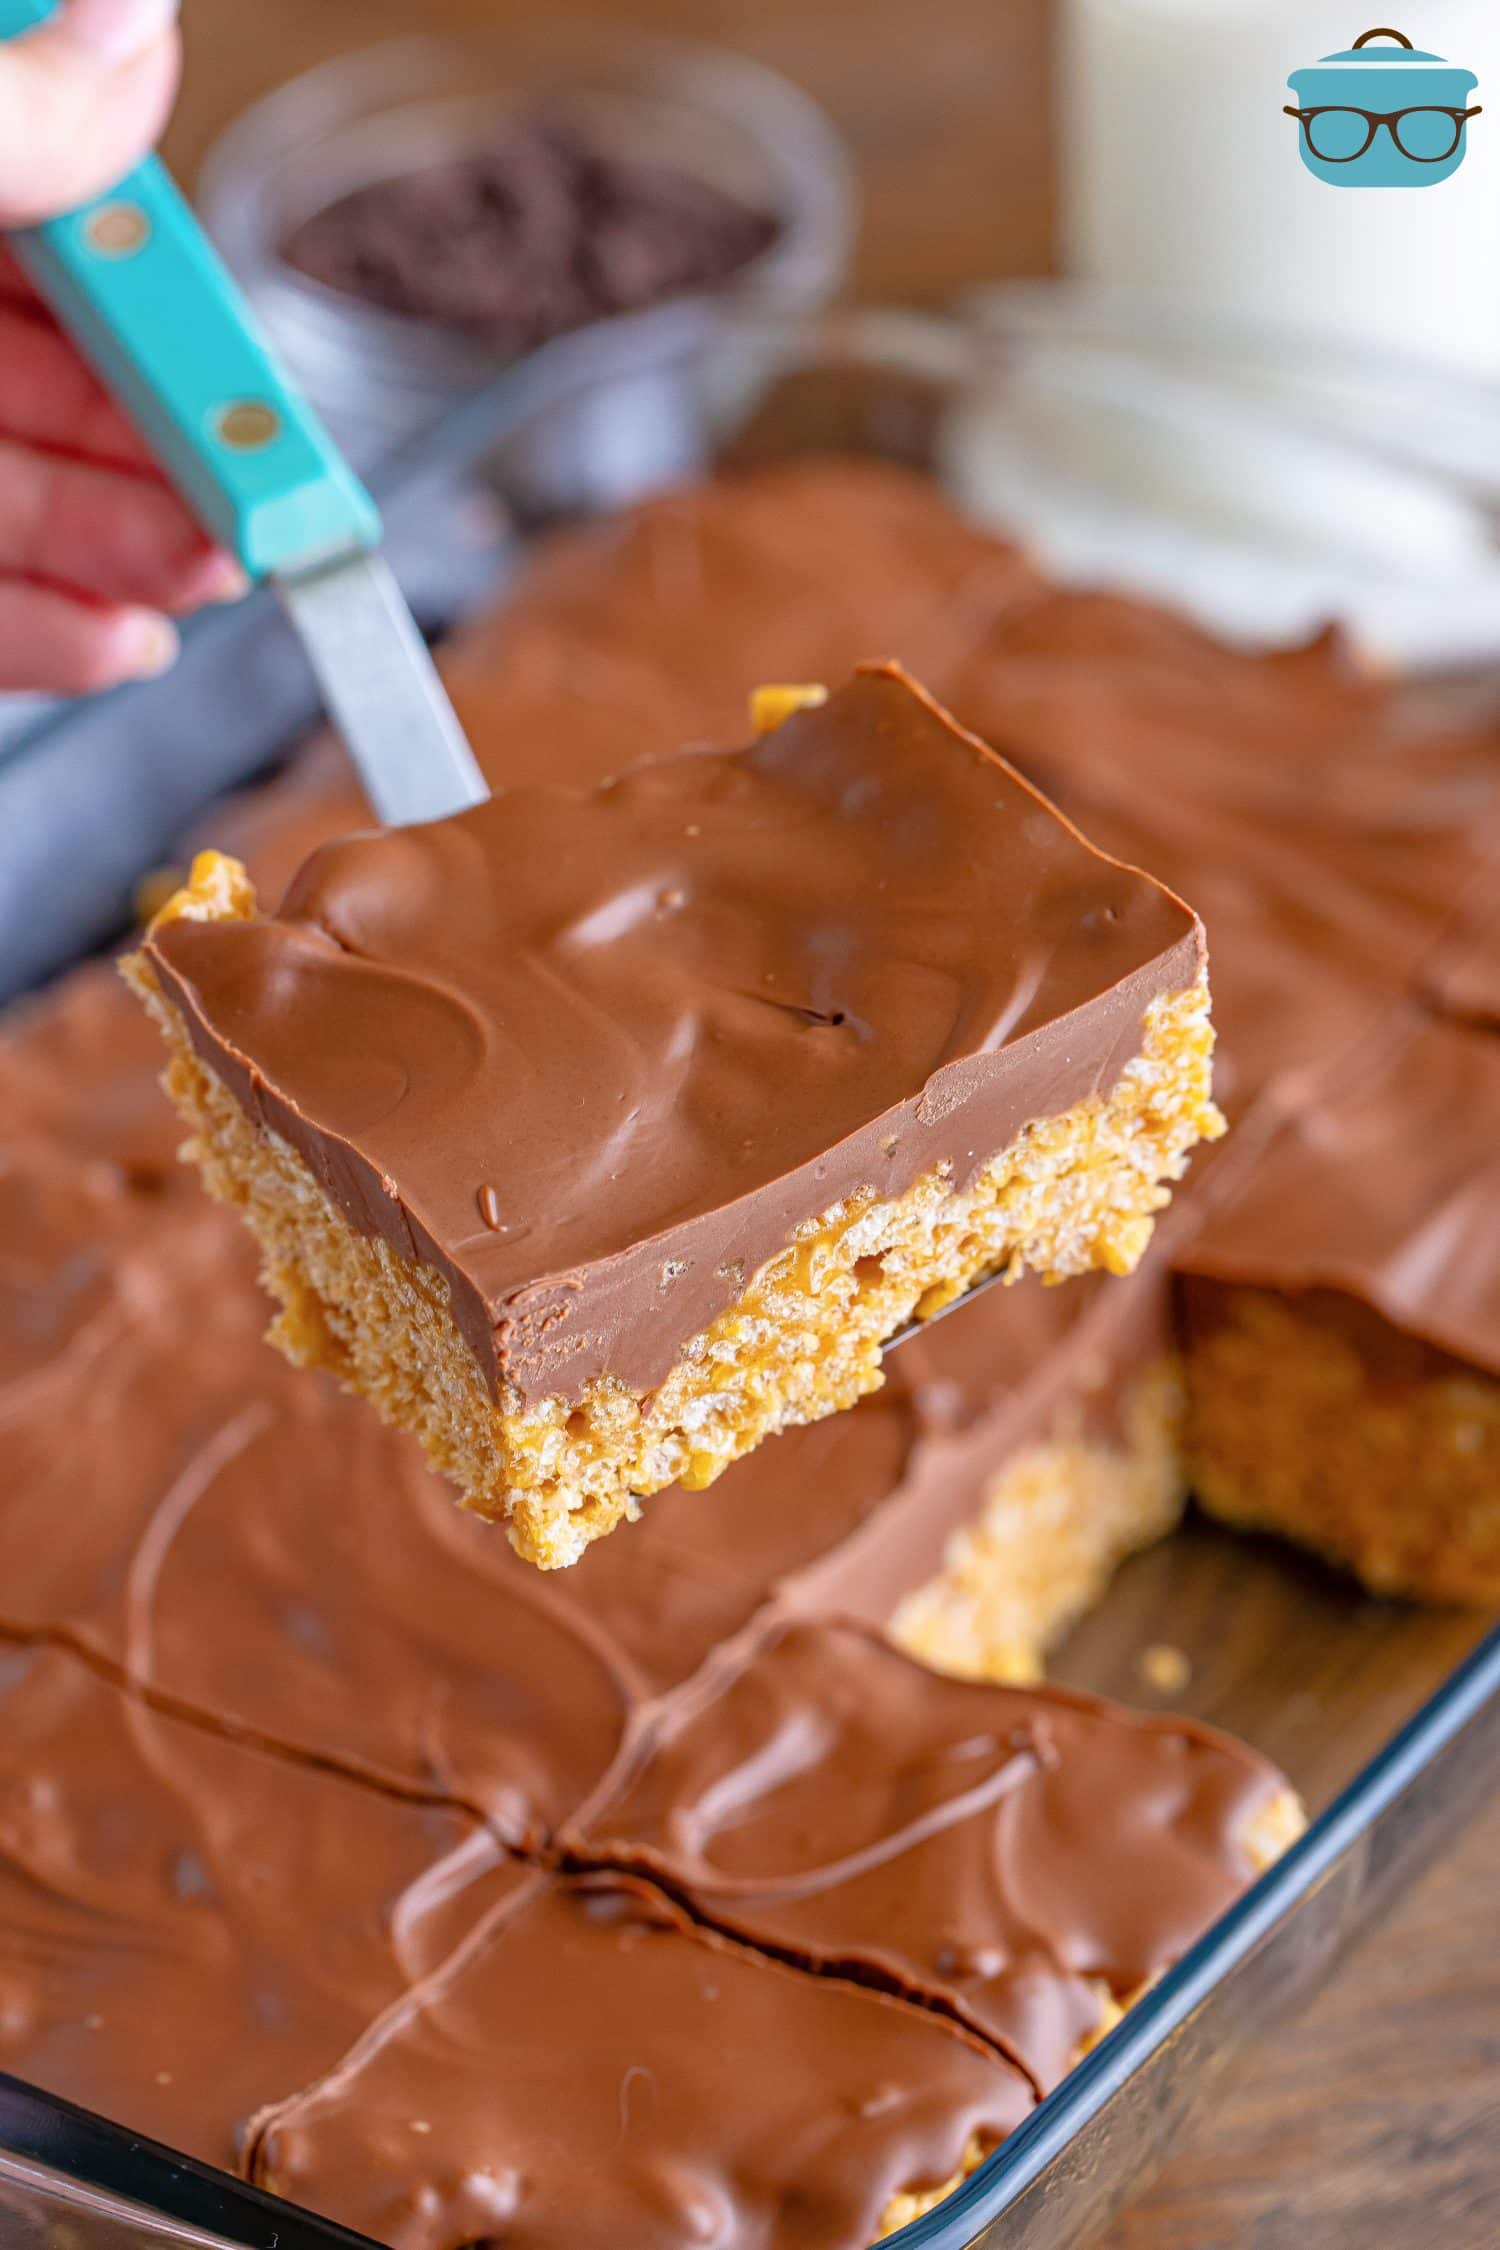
[0,0,245,695]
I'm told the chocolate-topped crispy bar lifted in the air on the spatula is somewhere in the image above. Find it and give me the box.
[135,664,1221,1568]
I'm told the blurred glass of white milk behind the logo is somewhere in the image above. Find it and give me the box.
[1061,0,1500,374]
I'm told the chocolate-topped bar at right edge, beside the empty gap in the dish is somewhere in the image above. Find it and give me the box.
[1181,1008,1500,1602]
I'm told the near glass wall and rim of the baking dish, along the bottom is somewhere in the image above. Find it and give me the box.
[0,1620,1500,2250]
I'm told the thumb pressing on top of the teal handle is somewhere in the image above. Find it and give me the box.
[0,0,178,230]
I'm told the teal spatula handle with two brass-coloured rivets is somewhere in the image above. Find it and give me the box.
[0,0,380,578]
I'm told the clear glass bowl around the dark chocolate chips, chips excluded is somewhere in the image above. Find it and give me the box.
[198,16,855,466]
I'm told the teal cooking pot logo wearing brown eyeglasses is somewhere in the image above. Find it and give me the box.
[1286,29,1480,187]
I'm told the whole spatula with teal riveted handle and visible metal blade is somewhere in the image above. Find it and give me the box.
[0,0,488,826]
